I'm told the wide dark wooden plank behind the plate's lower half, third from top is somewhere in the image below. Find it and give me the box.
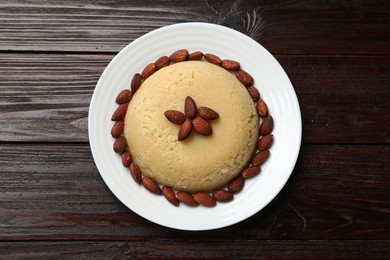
[0,144,390,241]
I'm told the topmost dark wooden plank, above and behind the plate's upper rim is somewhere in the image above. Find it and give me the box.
[0,0,390,54]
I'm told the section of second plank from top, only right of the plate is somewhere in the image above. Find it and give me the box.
[276,56,390,143]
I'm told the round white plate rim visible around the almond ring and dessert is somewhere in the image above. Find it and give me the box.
[88,23,302,230]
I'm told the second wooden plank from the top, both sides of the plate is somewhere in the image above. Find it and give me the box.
[0,53,390,143]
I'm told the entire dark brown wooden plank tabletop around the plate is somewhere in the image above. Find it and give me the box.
[0,0,390,259]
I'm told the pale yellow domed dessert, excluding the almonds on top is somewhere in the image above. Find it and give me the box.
[125,61,259,192]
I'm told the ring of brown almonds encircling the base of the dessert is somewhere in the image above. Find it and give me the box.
[111,49,274,207]
